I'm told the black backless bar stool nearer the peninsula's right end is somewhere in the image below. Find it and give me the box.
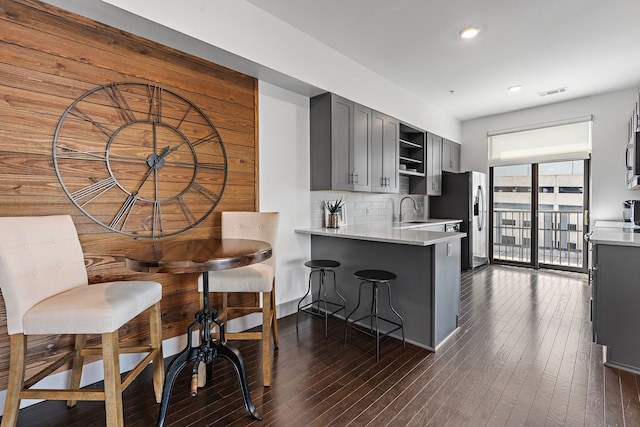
[344,270,406,362]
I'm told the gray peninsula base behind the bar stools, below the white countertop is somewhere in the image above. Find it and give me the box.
[311,235,460,351]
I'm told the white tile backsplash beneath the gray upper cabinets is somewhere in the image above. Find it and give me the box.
[311,182,428,228]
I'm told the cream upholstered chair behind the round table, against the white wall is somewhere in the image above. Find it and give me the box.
[199,211,280,387]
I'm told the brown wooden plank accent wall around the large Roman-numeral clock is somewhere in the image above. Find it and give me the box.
[0,0,258,389]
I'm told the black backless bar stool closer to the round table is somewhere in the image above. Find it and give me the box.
[296,259,347,337]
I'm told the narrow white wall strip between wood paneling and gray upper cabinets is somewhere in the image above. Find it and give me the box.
[259,81,311,317]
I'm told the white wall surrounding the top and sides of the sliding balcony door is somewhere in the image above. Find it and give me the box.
[461,89,640,224]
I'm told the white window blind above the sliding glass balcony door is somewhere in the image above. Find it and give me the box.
[488,116,592,166]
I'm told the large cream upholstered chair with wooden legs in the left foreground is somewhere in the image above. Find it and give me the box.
[0,215,164,427]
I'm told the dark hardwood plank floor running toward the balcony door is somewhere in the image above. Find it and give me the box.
[6,265,640,427]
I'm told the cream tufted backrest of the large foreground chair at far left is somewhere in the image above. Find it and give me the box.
[0,215,88,335]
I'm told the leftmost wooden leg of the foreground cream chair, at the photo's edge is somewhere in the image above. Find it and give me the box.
[2,334,27,427]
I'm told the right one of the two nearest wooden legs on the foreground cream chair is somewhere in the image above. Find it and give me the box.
[102,331,124,427]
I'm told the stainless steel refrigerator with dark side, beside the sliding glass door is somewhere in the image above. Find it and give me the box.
[429,172,489,270]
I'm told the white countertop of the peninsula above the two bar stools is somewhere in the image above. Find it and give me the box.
[295,220,467,246]
